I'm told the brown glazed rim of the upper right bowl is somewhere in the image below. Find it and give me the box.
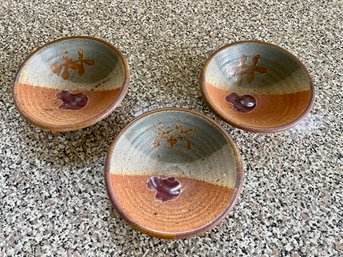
[199,40,315,133]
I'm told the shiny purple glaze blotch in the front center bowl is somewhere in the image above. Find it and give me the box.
[147,176,181,202]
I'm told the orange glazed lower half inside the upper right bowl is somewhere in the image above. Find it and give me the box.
[206,84,311,128]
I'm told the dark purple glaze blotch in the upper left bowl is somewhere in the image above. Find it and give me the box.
[56,90,88,110]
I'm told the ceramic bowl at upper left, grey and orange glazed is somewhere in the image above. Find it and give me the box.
[13,37,129,131]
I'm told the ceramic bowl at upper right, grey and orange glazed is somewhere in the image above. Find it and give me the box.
[200,41,314,132]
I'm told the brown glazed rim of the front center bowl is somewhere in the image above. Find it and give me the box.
[104,108,243,239]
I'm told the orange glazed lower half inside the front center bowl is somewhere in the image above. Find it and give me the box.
[109,174,234,233]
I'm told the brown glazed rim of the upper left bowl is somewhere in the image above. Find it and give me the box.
[12,36,130,132]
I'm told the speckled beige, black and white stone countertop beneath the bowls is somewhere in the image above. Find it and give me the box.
[0,0,343,257]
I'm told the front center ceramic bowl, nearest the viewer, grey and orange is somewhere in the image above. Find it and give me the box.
[105,108,243,239]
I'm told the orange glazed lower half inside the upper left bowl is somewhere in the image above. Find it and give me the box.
[15,84,120,126]
